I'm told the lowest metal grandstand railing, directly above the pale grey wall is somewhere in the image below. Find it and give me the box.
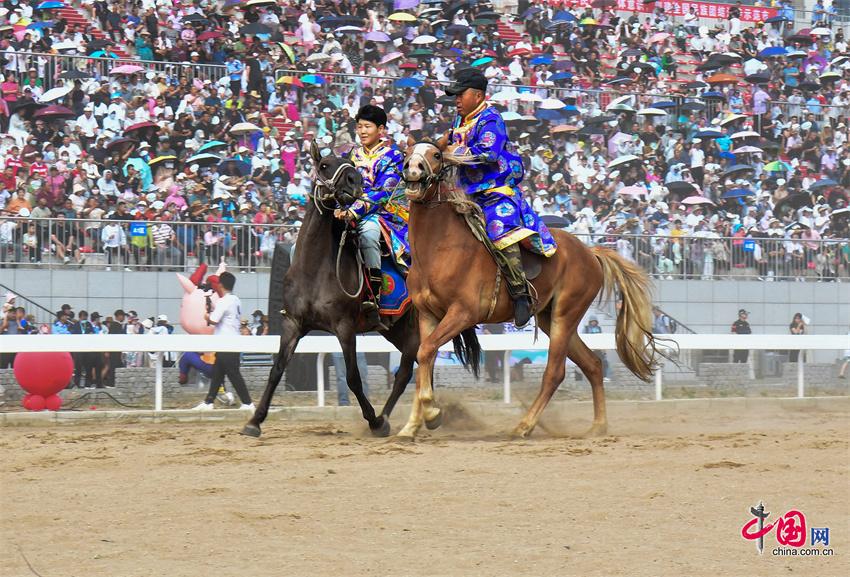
[0,217,850,281]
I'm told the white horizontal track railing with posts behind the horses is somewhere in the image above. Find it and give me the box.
[0,333,850,411]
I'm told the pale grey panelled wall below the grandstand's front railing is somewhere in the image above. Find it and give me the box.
[0,268,850,334]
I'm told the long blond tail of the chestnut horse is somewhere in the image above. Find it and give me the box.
[592,247,662,381]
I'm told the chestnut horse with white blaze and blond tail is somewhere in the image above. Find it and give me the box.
[399,142,658,438]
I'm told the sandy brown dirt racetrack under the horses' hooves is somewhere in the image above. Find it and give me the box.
[0,398,850,577]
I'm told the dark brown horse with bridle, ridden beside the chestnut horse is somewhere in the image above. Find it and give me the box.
[242,143,419,437]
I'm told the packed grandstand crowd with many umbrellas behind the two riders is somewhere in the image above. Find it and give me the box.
[0,0,850,279]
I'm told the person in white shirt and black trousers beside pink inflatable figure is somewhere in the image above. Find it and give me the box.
[195,272,254,413]
